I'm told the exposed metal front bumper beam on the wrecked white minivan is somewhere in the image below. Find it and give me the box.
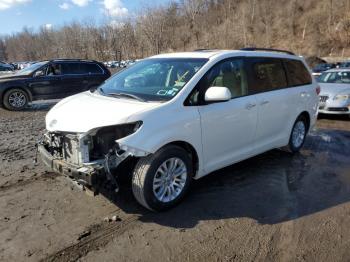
[38,144,106,187]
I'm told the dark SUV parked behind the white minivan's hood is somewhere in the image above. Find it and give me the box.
[0,59,111,110]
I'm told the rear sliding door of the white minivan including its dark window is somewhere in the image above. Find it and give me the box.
[248,57,300,153]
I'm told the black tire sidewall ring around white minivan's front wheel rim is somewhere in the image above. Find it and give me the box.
[144,146,193,211]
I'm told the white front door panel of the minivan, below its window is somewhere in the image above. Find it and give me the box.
[199,95,258,173]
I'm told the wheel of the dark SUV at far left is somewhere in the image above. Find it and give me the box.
[2,88,29,111]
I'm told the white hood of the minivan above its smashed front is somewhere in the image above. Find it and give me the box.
[46,91,159,133]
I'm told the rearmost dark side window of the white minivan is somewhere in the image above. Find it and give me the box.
[284,60,312,86]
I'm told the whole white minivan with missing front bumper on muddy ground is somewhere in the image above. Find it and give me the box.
[38,49,319,211]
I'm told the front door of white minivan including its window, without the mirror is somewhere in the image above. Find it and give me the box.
[198,58,257,172]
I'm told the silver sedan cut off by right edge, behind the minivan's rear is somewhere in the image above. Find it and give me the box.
[317,68,350,116]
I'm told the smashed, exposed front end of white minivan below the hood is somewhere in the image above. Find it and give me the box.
[37,121,148,192]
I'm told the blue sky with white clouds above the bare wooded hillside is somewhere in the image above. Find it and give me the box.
[0,0,169,35]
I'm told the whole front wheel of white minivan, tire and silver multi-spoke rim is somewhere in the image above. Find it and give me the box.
[132,145,193,211]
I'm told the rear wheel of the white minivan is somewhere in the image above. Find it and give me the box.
[288,116,308,153]
